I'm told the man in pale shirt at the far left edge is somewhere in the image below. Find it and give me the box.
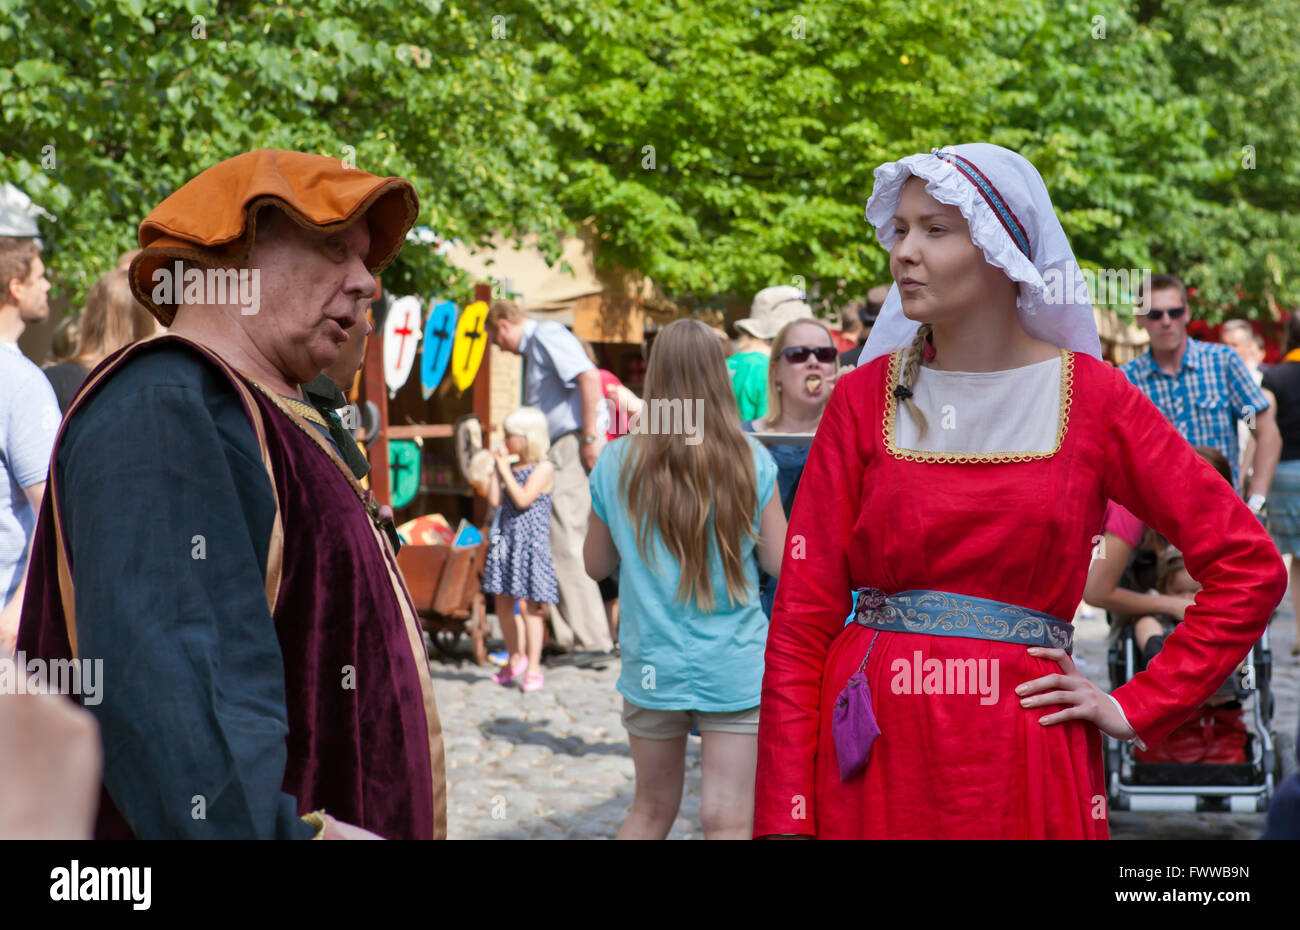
[0,237,60,658]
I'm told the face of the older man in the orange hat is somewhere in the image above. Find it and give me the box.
[244,211,374,384]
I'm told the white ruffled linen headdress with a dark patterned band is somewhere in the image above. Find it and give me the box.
[858,142,1101,365]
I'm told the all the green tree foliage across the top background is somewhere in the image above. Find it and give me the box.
[0,0,1300,316]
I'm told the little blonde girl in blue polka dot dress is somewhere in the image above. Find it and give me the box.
[484,407,559,691]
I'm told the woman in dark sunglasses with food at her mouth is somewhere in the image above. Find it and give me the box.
[742,317,840,617]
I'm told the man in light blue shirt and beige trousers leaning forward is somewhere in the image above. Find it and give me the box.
[484,300,614,652]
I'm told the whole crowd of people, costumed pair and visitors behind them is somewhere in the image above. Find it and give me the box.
[0,143,1300,839]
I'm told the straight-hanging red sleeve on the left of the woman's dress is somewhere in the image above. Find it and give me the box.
[754,372,875,836]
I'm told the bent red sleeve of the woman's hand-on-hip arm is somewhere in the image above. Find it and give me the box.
[1104,358,1287,745]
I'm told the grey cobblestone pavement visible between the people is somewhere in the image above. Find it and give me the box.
[430,598,1300,839]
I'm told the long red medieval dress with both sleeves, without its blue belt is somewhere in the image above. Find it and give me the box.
[754,352,1287,839]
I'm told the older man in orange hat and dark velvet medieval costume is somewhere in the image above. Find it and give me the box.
[18,151,446,839]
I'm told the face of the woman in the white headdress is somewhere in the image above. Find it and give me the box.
[889,177,1017,324]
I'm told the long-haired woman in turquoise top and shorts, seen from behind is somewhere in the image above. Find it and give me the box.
[584,320,785,839]
